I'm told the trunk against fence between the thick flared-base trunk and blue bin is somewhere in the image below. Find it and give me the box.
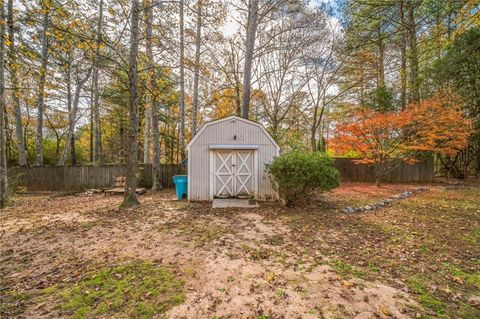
[145,0,162,191]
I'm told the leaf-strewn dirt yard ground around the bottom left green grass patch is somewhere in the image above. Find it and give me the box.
[0,183,480,319]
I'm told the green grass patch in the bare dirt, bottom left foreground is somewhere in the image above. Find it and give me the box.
[50,261,185,318]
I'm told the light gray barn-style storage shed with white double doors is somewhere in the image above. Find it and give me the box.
[187,116,280,201]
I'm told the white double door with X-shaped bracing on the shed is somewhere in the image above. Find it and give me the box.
[212,150,256,198]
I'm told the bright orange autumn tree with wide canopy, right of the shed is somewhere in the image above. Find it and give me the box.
[330,90,472,185]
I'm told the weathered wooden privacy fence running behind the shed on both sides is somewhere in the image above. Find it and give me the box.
[8,158,434,191]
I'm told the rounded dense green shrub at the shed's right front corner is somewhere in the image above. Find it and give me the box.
[267,151,340,206]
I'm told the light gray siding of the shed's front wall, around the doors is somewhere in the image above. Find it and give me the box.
[188,119,277,201]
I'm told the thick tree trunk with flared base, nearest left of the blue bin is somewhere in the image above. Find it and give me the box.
[121,0,140,207]
